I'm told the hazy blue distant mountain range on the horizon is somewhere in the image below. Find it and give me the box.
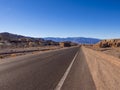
[44,37,101,44]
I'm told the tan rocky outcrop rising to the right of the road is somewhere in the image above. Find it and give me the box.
[94,39,120,48]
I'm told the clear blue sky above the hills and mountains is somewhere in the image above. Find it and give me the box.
[0,0,120,39]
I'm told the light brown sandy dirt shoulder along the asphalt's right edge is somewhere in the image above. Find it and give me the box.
[82,47,120,90]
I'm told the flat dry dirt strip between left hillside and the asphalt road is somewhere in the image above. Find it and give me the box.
[0,46,60,59]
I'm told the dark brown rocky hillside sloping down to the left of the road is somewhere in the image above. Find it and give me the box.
[0,32,58,48]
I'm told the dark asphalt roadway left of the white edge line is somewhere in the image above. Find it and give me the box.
[0,47,79,90]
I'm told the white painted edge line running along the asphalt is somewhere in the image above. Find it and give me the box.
[54,52,78,90]
